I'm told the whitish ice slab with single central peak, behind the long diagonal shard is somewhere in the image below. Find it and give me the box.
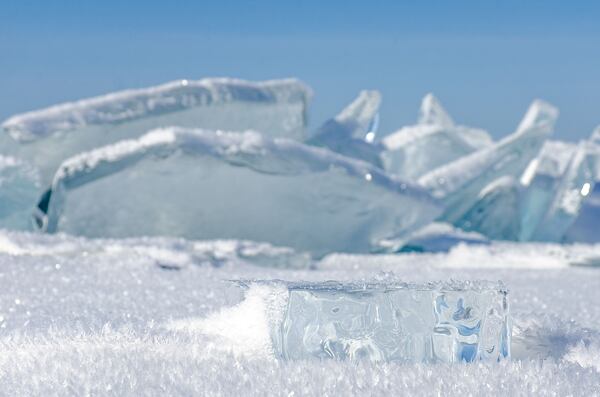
[381,94,492,179]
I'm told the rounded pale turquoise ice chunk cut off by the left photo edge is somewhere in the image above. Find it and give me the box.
[0,155,40,230]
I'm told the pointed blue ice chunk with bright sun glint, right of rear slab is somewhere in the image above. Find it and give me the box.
[307,90,381,167]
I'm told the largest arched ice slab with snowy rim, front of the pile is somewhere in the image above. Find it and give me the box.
[37,128,440,255]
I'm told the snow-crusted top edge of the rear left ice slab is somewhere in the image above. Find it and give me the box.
[2,78,312,142]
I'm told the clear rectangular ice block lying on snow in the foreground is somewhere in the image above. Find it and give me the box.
[232,280,511,363]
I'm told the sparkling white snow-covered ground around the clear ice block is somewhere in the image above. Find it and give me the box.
[0,227,600,396]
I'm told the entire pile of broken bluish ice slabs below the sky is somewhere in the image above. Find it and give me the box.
[0,79,600,256]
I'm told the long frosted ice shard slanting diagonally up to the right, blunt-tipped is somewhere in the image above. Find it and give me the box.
[419,100,558,224]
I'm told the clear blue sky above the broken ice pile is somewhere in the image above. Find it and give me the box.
[0,0,600,140]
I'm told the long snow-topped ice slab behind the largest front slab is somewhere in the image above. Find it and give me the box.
[2,78,312,183]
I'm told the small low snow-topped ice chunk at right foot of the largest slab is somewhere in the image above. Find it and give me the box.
[400,222,490,252]
